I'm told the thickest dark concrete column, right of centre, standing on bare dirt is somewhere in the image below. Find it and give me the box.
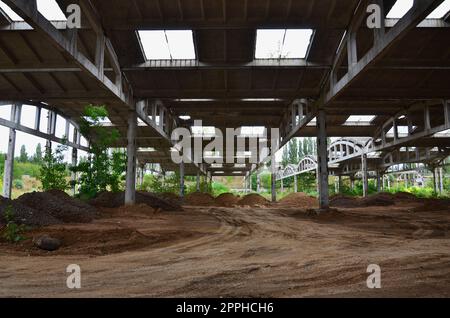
[317,109,330,209]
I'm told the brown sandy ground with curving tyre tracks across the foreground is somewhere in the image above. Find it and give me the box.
[0,204,450,297]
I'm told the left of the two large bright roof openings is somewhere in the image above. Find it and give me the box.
[138,30,195,60]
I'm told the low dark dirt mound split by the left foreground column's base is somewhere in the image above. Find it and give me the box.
[89,191,182,211]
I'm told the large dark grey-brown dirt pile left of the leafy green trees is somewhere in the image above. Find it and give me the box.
[15,191,99,223]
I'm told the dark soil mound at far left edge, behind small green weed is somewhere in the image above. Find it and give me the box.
[0,196,61,226]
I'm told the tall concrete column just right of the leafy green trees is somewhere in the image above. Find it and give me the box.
[125,112,137,205]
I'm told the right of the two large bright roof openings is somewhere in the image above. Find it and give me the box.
[255,29,313,59]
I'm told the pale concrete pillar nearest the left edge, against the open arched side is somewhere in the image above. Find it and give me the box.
[3,104,22,199]
